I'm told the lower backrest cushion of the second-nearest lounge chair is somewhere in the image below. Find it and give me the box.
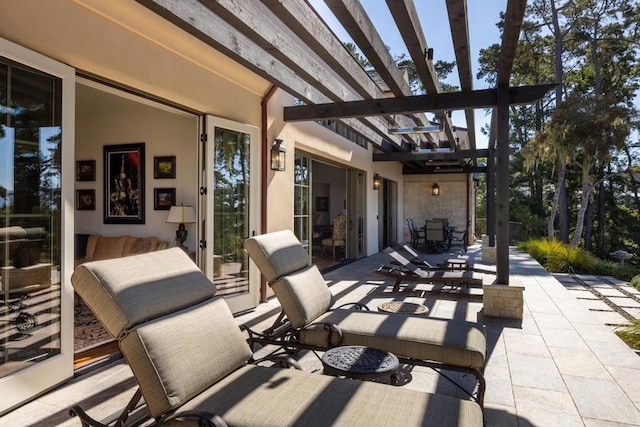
[271,265,334,328]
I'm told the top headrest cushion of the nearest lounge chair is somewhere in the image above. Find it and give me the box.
[71,248,216,337]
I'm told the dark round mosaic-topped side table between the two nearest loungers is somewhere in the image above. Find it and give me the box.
[322,345,400,383]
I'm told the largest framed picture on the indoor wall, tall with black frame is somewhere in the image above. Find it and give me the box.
[104,142,145,224]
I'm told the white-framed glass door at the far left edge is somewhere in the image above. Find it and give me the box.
[0,39,74,414]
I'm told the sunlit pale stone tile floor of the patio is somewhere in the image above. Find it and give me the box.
[0,246,640,427]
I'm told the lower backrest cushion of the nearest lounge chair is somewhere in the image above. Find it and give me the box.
[119,297,252,417]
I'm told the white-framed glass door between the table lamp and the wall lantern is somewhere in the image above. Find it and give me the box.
[205,117,259,312]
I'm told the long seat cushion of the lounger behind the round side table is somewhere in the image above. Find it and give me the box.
[300,309,487,370]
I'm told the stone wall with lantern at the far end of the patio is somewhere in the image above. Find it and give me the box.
[403,174,475,242]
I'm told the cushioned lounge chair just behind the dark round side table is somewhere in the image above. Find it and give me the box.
[245,230,486,405]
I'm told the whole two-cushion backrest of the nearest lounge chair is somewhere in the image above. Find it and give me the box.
[71,248,252,417]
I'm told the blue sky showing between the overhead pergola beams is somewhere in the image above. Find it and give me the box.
[308,0,507,148]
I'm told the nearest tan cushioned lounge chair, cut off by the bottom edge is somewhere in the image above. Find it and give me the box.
[71,248,482,427]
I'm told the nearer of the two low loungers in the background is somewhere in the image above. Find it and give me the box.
[376,247,483,292]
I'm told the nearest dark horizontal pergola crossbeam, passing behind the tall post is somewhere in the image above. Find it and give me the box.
[284,84,555,122]
